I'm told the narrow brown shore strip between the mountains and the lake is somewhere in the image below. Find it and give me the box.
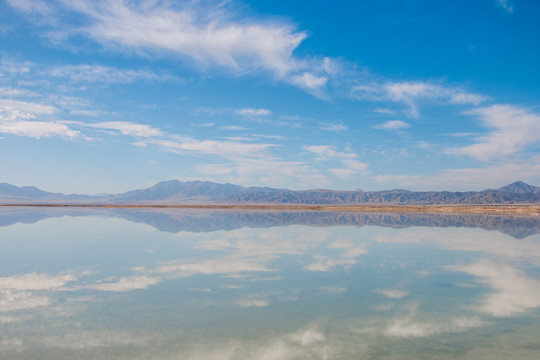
[0,204,540,215]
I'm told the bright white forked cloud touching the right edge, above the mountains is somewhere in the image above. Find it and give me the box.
[447,104,540,161]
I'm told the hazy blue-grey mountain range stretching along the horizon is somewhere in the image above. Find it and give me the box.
[0,180,540,205]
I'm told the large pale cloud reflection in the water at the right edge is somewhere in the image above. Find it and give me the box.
[454,260,540,316]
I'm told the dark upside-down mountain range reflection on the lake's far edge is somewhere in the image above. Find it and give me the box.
[0,207,540,239]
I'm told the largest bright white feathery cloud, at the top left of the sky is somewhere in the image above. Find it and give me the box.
[11,0,306,77]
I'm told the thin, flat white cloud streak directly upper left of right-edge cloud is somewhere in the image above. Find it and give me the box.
[352,81,487,118]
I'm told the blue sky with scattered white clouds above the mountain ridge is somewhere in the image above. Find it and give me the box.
[0,0,540,194]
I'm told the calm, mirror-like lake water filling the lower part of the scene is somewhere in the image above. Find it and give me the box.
[0,208,540,360]
